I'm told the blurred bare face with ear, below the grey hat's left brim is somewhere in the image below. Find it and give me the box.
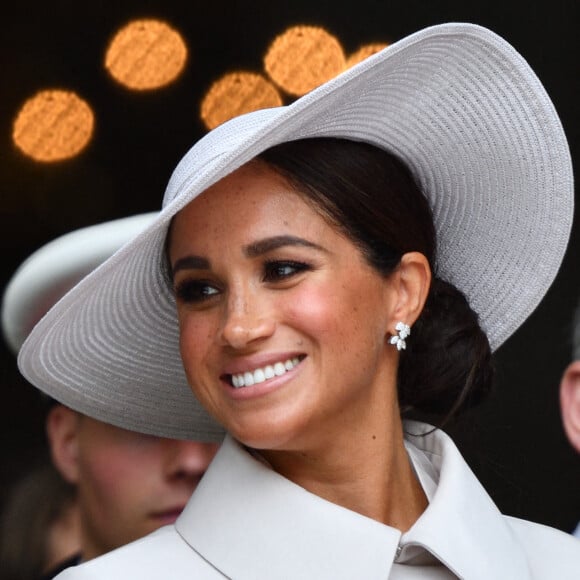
[47,404,217,560]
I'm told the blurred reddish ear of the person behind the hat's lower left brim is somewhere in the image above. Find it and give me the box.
[46,404,81,484]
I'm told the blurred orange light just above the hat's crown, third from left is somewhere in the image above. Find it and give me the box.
[201,71,282,129]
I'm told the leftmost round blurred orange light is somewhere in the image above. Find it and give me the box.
[12,90,95,162]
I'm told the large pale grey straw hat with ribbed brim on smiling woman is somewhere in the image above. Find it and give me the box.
[19,23,573,439]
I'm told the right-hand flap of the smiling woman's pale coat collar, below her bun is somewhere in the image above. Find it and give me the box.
[401,421,531,580]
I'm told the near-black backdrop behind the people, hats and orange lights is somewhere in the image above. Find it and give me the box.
[0,0,580,530]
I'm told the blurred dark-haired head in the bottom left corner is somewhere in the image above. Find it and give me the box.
[0,458,81,580]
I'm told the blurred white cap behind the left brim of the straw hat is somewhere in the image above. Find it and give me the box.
[2,212,159,354]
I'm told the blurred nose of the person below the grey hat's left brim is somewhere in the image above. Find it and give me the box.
[165,439,219,483]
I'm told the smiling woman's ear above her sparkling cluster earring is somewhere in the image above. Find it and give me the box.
[390,252,431,332]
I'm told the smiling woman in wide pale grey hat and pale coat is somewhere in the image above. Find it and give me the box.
[19,24,580,579]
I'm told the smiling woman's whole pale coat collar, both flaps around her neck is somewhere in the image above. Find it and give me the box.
[176,422,529,580]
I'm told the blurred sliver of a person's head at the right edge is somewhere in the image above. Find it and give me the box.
[560,306,580,453]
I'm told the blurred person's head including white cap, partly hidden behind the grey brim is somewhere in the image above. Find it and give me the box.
[2,213,218,560]
